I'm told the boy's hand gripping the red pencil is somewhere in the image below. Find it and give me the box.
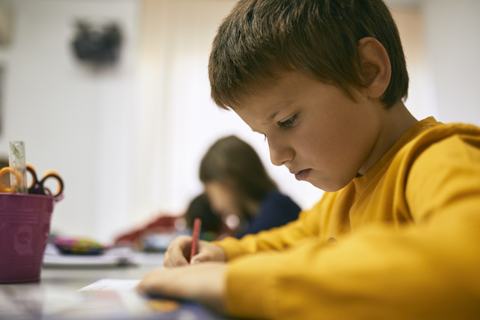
[163,236,227,268]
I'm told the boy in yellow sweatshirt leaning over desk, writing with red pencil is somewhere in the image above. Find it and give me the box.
[139,0,480,319]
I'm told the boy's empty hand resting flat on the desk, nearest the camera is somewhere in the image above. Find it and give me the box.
[137,262,226,312]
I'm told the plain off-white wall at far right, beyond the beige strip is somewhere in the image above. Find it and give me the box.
[423,0,480,125]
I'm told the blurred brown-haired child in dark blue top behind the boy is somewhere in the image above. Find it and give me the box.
[200,136,300,238]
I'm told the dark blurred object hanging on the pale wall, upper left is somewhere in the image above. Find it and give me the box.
[72,21,122,65]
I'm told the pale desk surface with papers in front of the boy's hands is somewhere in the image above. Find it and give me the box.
[0,257,232,320]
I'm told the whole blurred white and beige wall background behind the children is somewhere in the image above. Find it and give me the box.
[0,0,480,243]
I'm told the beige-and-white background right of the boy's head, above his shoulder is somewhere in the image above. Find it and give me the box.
[386,0,480,125]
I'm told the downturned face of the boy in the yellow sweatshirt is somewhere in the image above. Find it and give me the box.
[235,72,383,191]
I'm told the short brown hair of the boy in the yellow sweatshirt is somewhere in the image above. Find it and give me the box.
[209,0,408,109]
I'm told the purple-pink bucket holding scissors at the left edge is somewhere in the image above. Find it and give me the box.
[0,193,55,283]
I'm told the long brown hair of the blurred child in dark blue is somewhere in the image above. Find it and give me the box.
[200,136,277,201]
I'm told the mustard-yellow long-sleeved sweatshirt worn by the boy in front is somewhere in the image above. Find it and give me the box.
[213,118,480,320]
